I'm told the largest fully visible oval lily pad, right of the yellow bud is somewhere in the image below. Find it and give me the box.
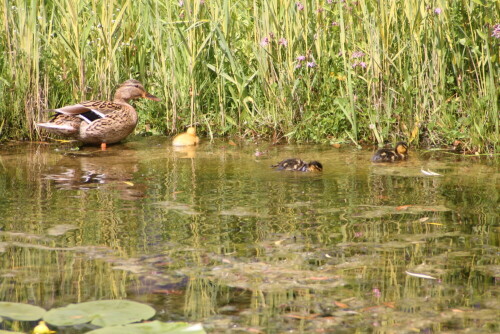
[44,300,156,327]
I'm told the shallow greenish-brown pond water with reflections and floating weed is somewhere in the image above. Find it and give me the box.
[0,137,500,333]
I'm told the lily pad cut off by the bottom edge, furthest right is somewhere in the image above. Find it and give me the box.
[87,321,206,334]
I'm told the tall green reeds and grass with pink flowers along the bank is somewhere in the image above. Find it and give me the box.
[0,0,500,151]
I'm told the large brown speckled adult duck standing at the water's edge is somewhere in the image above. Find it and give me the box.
[37,79,160,149]
